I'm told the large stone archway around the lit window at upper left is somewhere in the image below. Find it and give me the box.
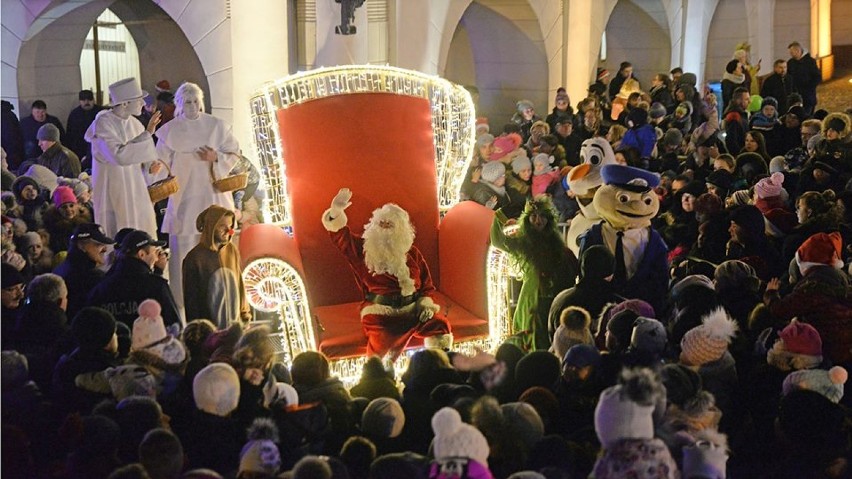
[2,0,232,125]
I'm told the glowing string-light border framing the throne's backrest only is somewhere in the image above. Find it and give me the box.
[251,65,476,225]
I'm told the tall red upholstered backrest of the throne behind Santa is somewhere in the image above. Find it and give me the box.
[277,93,440,306]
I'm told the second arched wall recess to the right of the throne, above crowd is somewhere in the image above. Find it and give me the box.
[606,0,672,91]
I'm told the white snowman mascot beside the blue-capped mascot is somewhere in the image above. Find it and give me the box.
[565,137,615,258]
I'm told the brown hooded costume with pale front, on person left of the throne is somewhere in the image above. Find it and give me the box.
[183,205,251,328]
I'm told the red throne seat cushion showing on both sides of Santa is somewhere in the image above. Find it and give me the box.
[312,293,488,359]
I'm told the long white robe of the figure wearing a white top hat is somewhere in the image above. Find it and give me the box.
[85,110,157,237]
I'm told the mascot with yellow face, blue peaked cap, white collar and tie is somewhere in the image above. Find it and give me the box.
[580,165,669,312]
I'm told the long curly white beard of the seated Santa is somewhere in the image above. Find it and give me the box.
[364,221,414,296]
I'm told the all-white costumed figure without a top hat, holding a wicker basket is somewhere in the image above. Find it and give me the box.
[157,83,240,313]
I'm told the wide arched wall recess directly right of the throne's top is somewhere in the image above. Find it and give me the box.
[444,0,549,129]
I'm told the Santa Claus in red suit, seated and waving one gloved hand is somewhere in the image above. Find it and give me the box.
[322,188,453,359]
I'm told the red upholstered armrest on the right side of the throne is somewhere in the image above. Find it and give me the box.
[438,201,494,318]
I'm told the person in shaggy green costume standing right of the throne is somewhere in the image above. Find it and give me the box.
[491,195,579,351]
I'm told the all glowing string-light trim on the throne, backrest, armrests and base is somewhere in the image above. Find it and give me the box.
[243,65,511,385]
